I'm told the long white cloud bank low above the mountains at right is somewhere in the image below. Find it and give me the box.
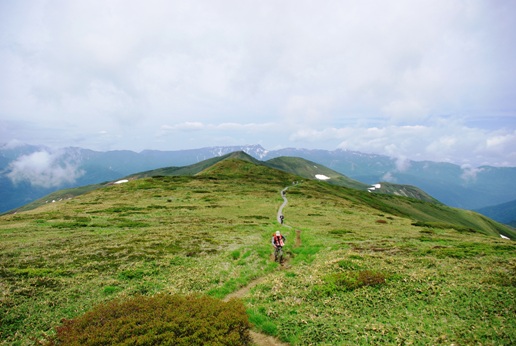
[290,121,516,167]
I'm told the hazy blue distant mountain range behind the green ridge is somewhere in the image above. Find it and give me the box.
[0,145,516,224]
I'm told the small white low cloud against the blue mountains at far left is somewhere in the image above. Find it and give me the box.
[7,151,85,188]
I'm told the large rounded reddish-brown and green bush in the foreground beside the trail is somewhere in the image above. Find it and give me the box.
[47,294,251,345]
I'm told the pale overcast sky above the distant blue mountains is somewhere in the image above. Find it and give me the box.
[0,0,516,167]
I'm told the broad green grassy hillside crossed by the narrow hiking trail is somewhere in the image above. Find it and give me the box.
[0,158,516,345]
